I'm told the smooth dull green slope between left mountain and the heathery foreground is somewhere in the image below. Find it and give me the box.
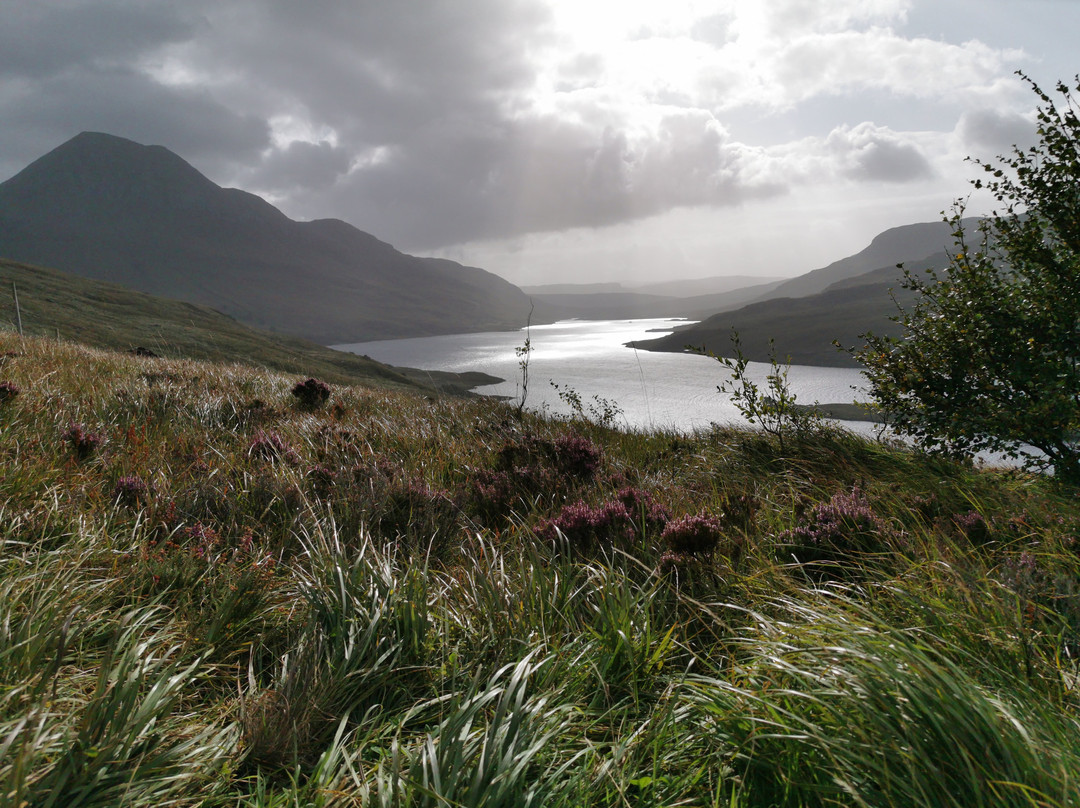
[0,258,494,391]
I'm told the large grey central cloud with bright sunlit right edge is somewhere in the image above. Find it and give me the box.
[185,0,781,247]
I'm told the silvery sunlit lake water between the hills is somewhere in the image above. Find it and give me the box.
[335,320,869,432]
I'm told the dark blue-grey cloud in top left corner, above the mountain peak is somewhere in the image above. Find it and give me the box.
[0,2,269,177]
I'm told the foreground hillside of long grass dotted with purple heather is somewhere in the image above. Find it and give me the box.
[0,333,1080,807]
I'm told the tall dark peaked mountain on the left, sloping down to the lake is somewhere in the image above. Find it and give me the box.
[0,132,544,345]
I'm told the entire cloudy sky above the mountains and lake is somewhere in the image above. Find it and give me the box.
[0,0,1080,285]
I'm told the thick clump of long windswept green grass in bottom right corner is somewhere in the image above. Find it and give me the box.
[688,601,1080,806]
